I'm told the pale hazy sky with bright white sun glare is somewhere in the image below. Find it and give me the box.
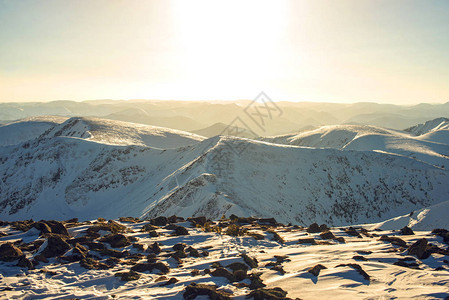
[0,0,449,104]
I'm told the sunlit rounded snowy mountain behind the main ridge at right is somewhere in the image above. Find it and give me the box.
[261,125,449,166]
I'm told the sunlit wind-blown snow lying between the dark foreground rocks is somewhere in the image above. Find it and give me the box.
[0,219,449,299]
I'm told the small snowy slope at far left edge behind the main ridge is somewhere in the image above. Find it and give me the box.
[0,116,67,146]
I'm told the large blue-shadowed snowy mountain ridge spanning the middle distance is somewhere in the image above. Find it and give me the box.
[0,118,449,225]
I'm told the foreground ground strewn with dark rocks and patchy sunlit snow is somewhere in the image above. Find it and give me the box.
[0,216,449,299]
